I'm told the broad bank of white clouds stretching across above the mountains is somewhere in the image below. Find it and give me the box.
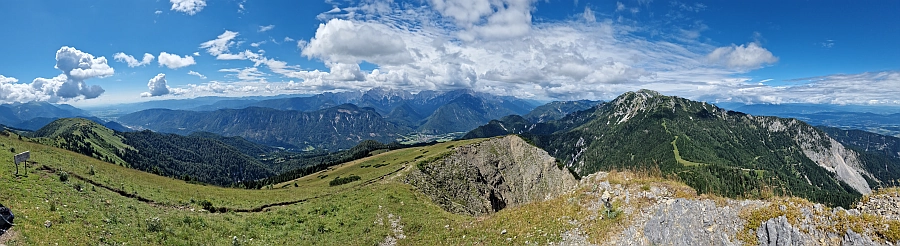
[0,0,900,104]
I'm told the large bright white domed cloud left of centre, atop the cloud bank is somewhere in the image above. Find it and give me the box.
[298,19,412,64]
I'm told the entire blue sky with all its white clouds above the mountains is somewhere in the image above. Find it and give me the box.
[0,0,900,106]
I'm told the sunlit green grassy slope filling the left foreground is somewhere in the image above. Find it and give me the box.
[0,131,592,245]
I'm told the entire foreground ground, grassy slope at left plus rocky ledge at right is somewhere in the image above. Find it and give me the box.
[0,136,900,245]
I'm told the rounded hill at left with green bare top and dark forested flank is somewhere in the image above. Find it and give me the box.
[31,118,280,186]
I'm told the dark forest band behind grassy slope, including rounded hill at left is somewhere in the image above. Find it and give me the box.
[31,118,418,188]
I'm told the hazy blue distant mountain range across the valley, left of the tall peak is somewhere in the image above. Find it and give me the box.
[117,88,535,150]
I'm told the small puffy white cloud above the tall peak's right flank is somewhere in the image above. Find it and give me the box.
[706,42,778,70]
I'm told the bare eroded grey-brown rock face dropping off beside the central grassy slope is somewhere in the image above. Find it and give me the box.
[405,136,576,216]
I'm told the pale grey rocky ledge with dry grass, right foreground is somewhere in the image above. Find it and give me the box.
[559,172,900,245]
